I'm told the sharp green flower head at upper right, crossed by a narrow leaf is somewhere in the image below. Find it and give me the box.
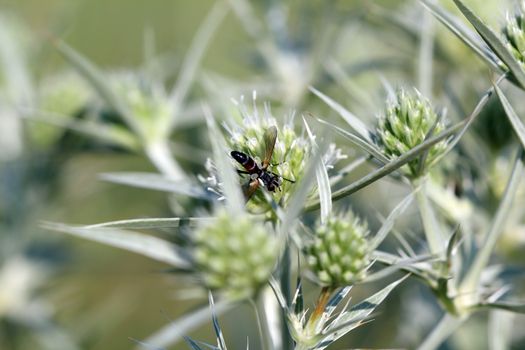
[376,89,447,178]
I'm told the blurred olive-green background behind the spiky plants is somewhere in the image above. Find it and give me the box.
[0,0,513,350]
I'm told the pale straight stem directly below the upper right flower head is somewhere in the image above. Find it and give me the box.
[413,177,446,257]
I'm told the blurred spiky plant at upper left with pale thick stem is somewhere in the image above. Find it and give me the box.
[28,2,228,186]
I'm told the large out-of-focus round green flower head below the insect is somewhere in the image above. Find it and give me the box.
[193,211,279,300]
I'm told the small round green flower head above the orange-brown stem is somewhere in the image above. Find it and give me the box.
[305,211,370,287]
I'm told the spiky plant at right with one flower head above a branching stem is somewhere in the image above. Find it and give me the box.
[309,63,523,349]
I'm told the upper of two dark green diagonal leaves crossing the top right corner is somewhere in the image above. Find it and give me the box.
[454,0,525,89]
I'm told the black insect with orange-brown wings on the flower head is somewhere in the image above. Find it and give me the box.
[230,126,295,200]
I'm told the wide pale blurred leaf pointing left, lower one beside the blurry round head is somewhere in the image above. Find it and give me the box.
[43,223,191,269]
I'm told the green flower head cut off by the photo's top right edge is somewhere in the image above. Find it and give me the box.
[503,1,525,69]
